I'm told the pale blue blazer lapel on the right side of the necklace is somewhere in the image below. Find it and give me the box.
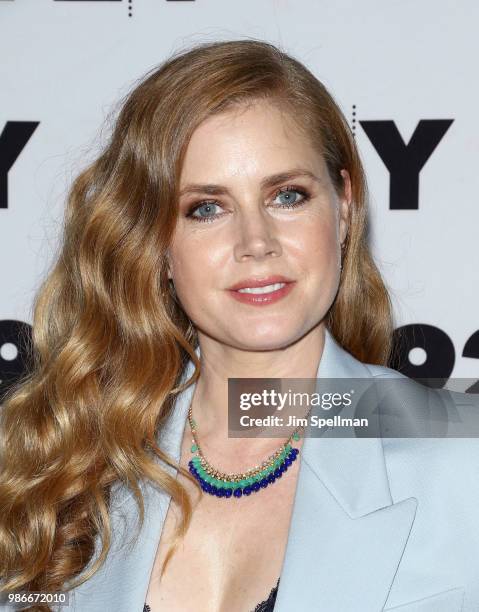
[275,331,417,612]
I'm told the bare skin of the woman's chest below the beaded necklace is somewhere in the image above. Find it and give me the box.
[146,454,299,612]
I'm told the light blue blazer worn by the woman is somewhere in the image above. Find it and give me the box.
[1,331,479,612]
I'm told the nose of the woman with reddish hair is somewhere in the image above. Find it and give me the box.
[234,209,282,262]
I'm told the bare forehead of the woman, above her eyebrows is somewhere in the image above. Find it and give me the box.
[180,101,324,184]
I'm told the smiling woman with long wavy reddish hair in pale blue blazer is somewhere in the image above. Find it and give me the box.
[0,40,479,612]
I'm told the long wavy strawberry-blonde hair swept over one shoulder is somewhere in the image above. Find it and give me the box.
[0,39,393,611]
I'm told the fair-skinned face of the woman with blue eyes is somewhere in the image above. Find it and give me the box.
[168,102,351,350]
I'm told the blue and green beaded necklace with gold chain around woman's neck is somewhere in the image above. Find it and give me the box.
[188,405,303,498]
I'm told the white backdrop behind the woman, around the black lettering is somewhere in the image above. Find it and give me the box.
[0,0,479,392]
